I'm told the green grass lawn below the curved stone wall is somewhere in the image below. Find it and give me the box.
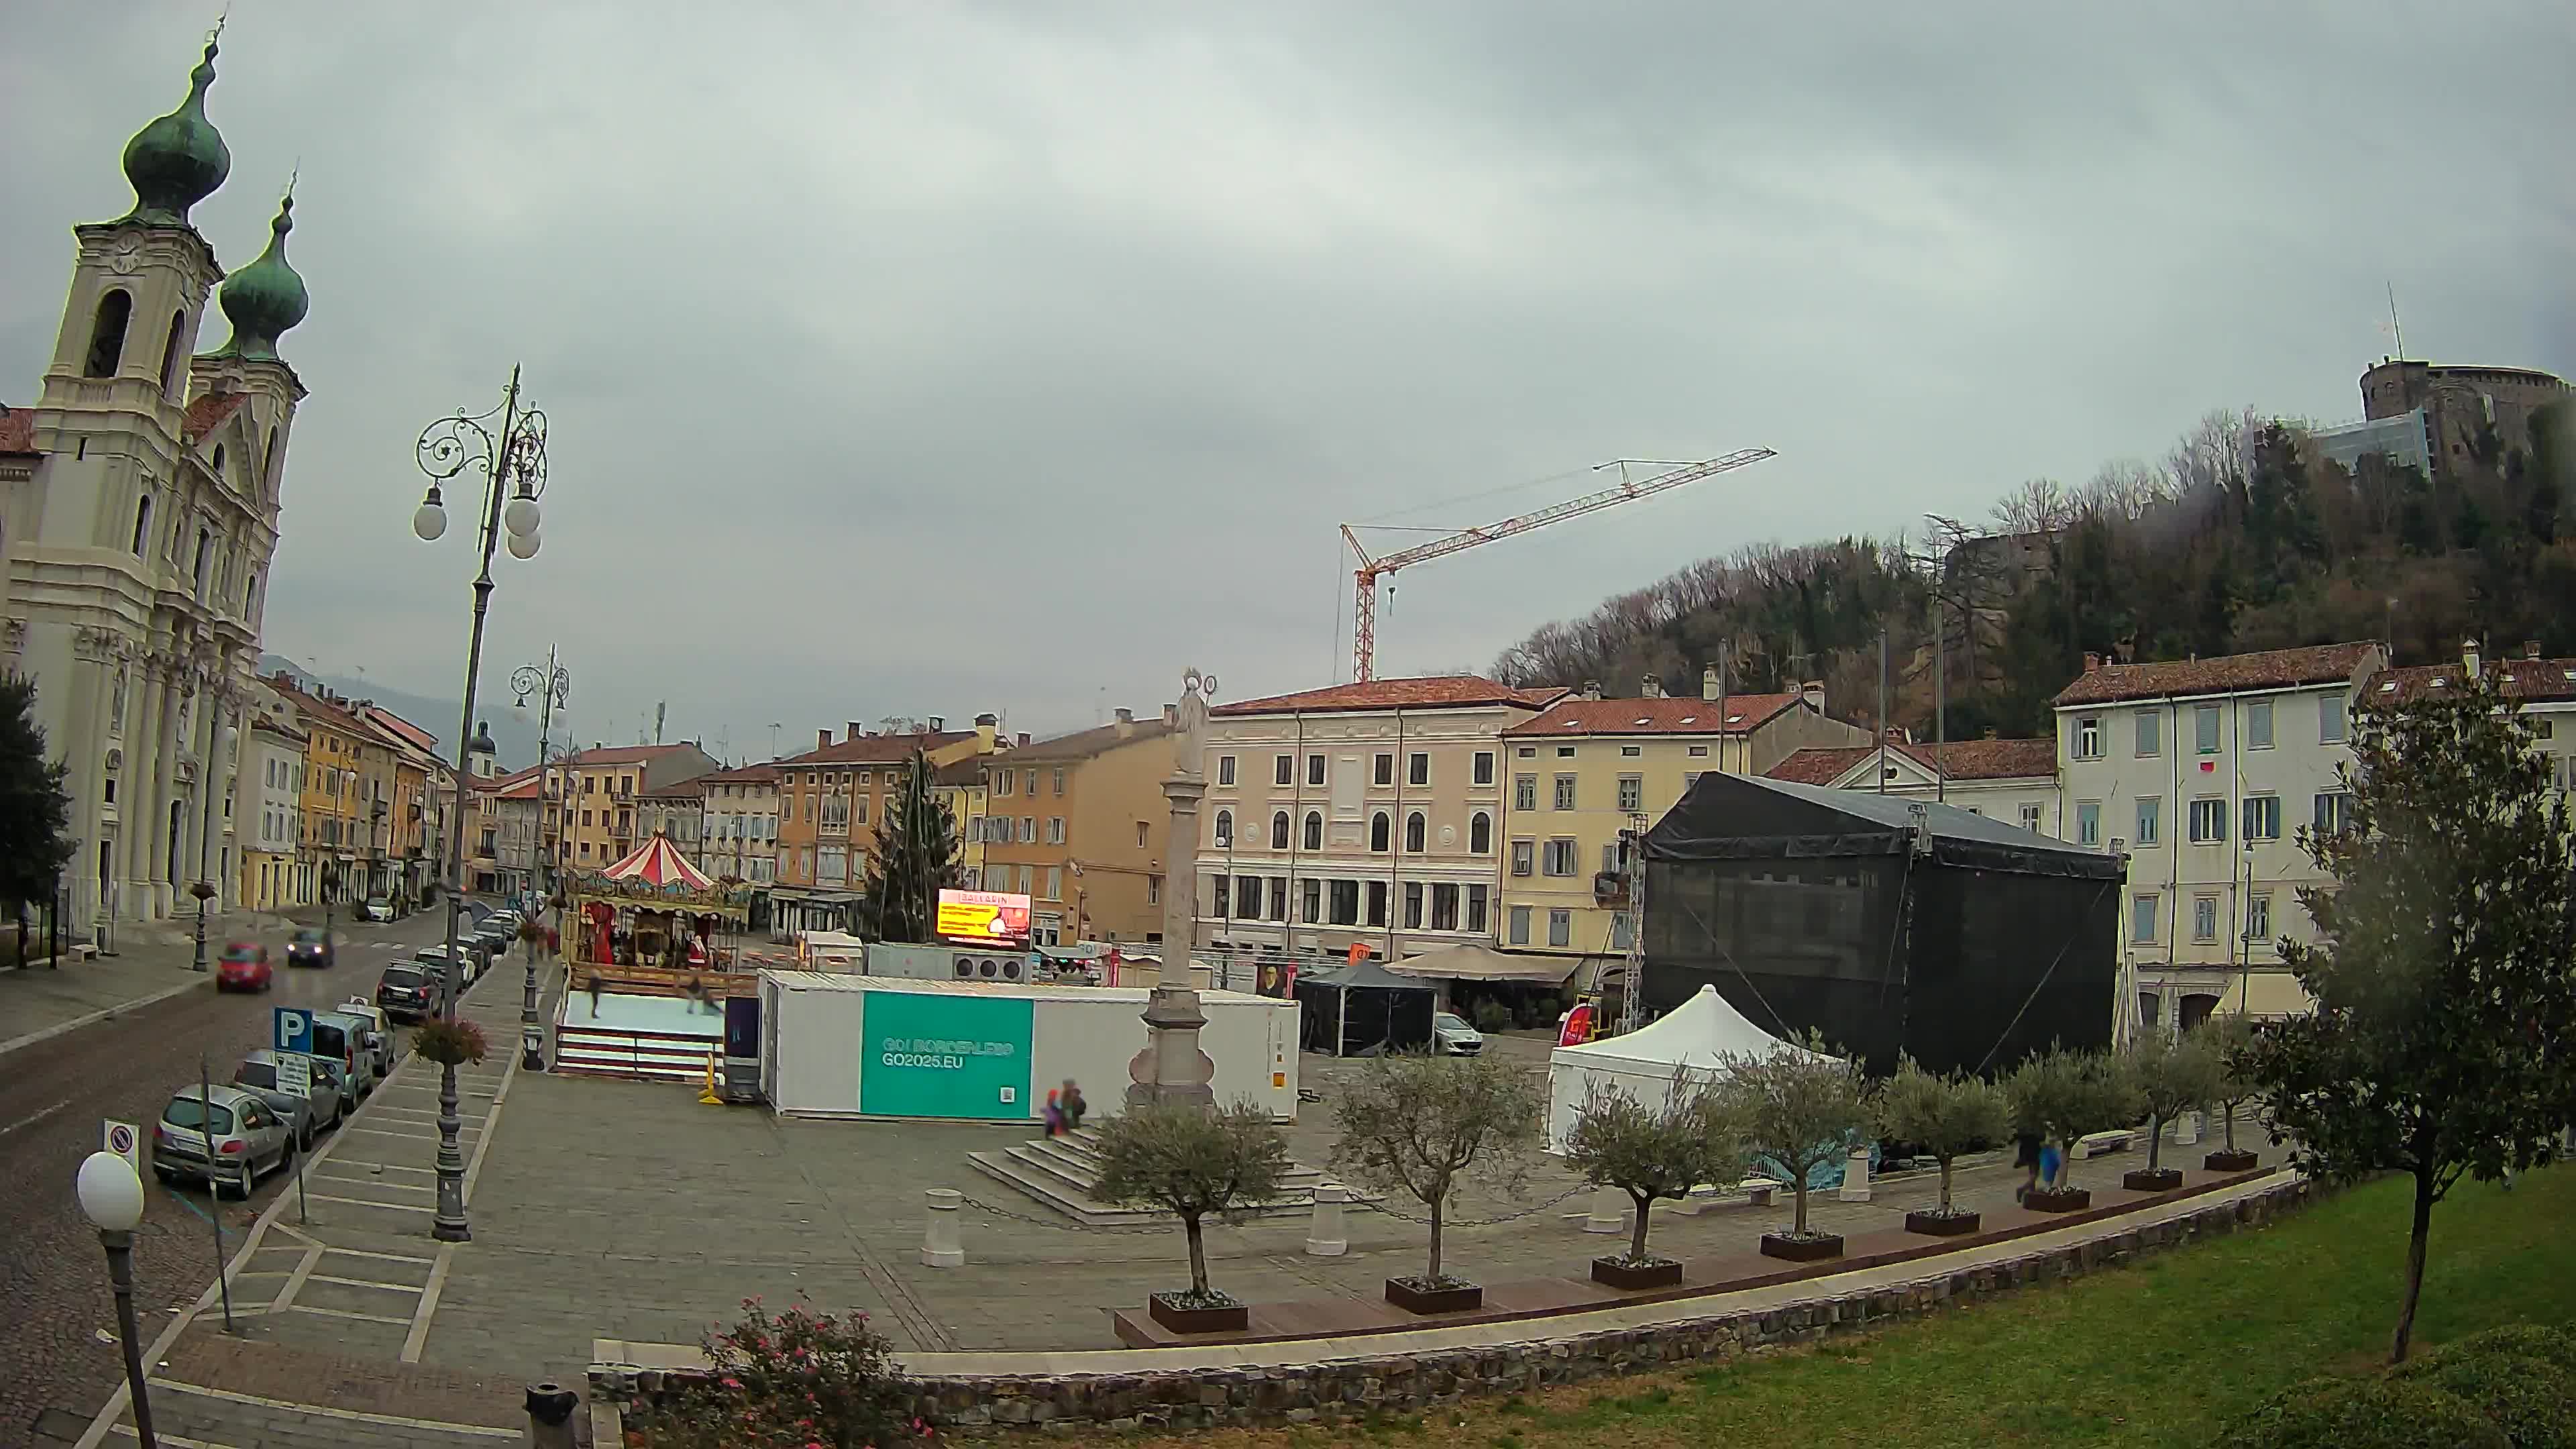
[1102,1168,2576,1449]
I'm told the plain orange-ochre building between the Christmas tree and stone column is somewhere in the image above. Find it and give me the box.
[981,706,1175,947]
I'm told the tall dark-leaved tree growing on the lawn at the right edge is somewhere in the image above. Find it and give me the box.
[2246,676,2576,1361]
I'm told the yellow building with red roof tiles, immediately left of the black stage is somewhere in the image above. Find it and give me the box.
[1497,670,1870,975]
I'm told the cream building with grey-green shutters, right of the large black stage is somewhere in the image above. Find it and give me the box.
[2053,642,2388,1029]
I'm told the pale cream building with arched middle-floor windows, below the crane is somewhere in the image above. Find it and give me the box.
[1179,676,1564,959]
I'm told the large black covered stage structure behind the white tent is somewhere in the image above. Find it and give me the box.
[1644,773,2125,1073]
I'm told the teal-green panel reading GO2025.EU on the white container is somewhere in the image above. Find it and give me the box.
[858,990,1036,1119]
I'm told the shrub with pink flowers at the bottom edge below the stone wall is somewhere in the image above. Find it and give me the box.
[629,1294,930,1449]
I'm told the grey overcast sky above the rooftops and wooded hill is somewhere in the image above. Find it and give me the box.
[0,0,2576,758]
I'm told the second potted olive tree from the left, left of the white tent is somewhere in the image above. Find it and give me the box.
[1332,1052,1546,1312]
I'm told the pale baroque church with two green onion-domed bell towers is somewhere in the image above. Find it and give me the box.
[0,41,307,928]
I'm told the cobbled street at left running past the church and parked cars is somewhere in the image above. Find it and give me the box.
[0,913,458,1444]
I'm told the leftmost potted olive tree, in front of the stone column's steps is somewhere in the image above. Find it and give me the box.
[1095,1101,1288,1333]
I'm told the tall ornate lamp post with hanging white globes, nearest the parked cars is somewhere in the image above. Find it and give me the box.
[412,366,546,1243]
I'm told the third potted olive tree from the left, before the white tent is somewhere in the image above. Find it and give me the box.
[1566,1067,1744,1289]
